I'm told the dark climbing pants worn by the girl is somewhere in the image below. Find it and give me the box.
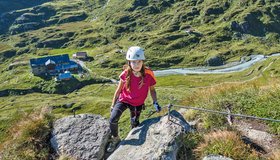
[110,101,144,137]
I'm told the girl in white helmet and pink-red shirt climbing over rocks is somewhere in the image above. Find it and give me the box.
[107,46,161,152]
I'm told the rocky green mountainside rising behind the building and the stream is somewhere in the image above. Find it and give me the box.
[0,0,280,67]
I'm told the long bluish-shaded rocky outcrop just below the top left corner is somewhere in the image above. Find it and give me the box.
[0,4,88,34]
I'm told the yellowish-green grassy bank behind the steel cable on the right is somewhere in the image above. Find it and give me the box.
[179,80,280,134]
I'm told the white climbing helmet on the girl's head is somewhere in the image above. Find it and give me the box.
[126,46,145,61]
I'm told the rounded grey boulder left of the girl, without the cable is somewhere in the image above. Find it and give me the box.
[51,114,110,160]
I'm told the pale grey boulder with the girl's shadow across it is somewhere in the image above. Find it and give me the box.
[108,111,191,160]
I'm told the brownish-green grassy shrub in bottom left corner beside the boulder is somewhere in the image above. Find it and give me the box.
[2,109,53,159]
